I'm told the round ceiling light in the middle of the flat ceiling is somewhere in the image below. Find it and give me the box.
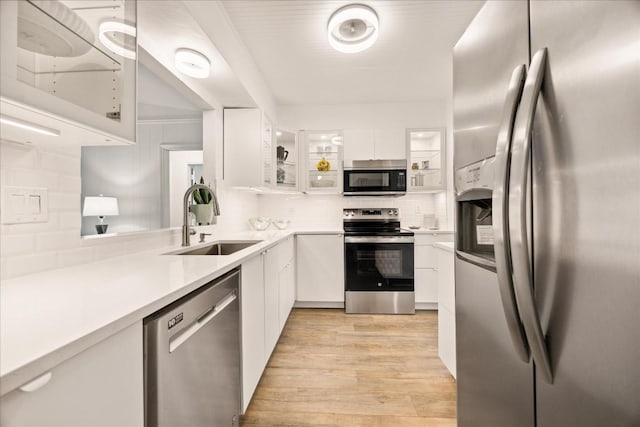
[327,4,379,53]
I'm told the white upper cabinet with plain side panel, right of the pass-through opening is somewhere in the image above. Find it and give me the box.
[223,108,276,188]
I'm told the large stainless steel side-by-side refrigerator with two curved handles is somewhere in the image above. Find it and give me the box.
[454,1,640,427]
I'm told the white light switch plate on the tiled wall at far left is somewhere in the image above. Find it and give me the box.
[0,186,49,224]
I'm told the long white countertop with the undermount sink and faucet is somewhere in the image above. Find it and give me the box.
[0,230,330,394]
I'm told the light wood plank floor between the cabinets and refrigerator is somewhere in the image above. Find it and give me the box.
[241,309,456,427]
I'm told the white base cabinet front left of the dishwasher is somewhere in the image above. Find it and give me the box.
[0,321,144,427]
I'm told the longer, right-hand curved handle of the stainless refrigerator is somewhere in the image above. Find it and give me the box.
[508,48,553,384]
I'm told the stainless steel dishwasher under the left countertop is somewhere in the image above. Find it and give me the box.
[144,269,240,427]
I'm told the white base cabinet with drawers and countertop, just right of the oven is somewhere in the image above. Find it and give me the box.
[414,233,453,310]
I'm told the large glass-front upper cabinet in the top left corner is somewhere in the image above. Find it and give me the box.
[0,0,137,143]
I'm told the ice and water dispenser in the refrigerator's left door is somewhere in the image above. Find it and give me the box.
[455,157,495,271]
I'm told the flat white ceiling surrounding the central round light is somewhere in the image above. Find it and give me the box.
[223,0,484,105]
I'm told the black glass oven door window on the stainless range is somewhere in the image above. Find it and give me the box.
[345,243,413,291]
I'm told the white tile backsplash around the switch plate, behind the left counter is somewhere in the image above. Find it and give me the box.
[0,141,188,279]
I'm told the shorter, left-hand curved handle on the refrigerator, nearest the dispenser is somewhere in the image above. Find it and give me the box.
[491,64,529,363]
